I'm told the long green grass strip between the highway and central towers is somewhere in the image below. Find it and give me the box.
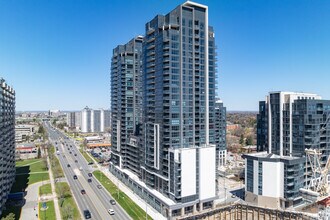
[93,170,152,219]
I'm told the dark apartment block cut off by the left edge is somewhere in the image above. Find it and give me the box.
[0,78,16,215]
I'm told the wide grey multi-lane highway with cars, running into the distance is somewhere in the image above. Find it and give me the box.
[44,123,131,220]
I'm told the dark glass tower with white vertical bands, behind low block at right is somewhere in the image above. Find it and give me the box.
[257,92,329,157]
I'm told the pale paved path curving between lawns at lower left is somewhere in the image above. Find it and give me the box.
[20,181,49,220]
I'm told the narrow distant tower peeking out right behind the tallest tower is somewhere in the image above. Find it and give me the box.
[215,100,227,167]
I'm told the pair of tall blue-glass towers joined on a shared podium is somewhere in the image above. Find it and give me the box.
[110,1,220,217]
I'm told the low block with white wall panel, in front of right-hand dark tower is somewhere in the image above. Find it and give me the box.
[243,152,305,209]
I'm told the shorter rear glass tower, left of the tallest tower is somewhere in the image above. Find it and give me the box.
[111,36,143,175]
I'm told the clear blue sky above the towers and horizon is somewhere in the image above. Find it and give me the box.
[0,0,330,110]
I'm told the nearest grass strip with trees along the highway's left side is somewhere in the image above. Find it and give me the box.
[55,182,81,219]
